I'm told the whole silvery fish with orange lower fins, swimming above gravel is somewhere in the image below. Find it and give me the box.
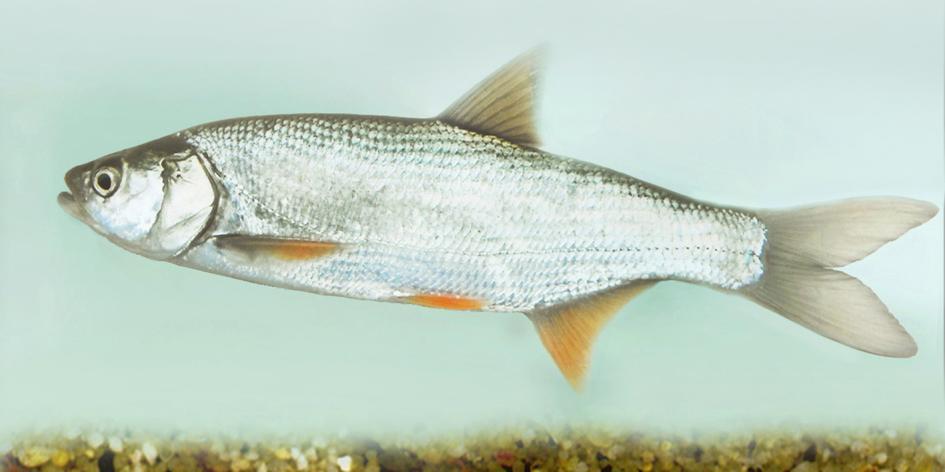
[58,51,938,389]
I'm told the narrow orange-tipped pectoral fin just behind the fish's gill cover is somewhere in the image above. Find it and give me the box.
[214,235,340,261]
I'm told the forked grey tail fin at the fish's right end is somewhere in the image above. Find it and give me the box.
[742,197,938,357]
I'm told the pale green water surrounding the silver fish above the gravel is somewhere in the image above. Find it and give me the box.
[0,0,945,440]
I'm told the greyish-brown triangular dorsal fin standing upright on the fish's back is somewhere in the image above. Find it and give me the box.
[437,49,542,147]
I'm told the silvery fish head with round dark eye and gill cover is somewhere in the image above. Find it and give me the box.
[58,135,217,260]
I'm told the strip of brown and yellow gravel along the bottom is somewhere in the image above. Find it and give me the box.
[0,430,945,472]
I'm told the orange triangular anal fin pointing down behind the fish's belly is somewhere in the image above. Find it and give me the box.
[527,280,656,390]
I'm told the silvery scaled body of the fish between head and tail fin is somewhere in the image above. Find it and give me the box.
[179,115,765,311]
